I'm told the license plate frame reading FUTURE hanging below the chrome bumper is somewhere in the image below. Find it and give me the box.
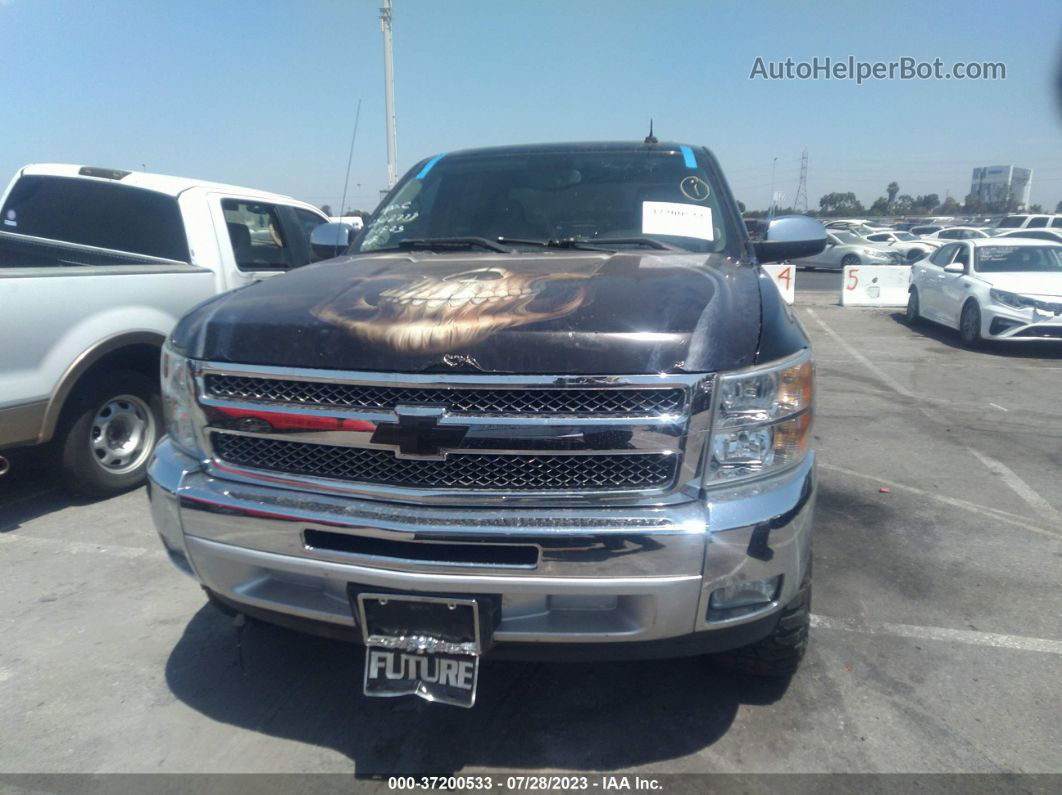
[352,591,483,708]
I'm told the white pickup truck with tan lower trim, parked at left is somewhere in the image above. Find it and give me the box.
[0,165,328,495]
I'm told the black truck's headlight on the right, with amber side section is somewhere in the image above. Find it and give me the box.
[704,350,815,486]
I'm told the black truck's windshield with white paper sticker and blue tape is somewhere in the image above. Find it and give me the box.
[353,146,740,253]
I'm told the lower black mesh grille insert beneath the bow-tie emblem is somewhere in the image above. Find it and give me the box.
[211,433,678,491]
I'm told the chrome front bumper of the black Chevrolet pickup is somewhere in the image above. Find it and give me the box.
[149,439,815,647]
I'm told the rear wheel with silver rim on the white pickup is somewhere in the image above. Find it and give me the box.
[61,370,162,497]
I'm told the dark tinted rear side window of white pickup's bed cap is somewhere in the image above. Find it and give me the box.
[0,174,190,262]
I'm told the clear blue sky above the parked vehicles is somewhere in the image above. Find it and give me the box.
[0,0,1062,209]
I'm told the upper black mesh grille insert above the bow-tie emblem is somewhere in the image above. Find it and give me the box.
[204,375,685,417]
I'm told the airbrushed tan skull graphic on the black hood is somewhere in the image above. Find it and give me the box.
[313,265,589,353]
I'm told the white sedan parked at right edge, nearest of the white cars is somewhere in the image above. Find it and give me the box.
[907,238,1062,347]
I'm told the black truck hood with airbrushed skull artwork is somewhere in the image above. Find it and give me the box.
[171,250,760,375]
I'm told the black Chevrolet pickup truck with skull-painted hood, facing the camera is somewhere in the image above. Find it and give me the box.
[150,140,825,706]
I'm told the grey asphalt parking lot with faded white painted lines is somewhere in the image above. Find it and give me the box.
[0,292,1062,775]
